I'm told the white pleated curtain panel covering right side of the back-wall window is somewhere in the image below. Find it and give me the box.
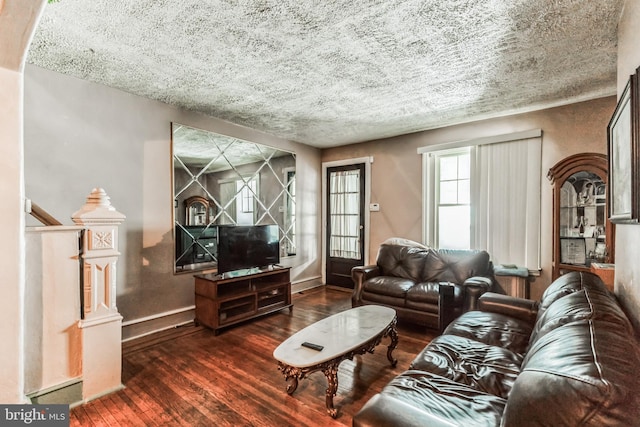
[471,138,542,270]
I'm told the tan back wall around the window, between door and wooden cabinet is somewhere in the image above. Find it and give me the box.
[322,97,615,298]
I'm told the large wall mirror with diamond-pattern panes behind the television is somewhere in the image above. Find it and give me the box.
[171,123,296,273]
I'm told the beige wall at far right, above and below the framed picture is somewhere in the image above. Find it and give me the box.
[615,0,640,331]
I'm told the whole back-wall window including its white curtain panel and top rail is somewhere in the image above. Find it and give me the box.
[418,130,542,271]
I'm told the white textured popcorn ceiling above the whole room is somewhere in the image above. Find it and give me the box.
[28,0,623,147]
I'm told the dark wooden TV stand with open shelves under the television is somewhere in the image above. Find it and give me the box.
[194,267,293,335]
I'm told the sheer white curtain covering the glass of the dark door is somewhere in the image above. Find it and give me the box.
[329,170,360,259]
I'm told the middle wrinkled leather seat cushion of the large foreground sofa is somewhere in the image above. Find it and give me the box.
[409,335,522,399]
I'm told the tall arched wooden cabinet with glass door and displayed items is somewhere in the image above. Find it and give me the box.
[547,153,614,280]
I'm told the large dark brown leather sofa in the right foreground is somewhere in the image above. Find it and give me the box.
[353,272,640,427]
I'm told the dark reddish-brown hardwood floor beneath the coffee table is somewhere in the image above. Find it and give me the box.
[70,287,436,427]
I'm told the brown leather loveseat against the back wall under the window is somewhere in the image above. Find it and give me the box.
[351,238,496,331]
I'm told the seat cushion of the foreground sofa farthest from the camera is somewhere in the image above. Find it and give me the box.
[444,311,533,354]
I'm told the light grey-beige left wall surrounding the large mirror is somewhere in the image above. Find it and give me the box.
[24,65,321,339]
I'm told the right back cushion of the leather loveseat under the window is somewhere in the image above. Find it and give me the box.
[421,249,493,284]
